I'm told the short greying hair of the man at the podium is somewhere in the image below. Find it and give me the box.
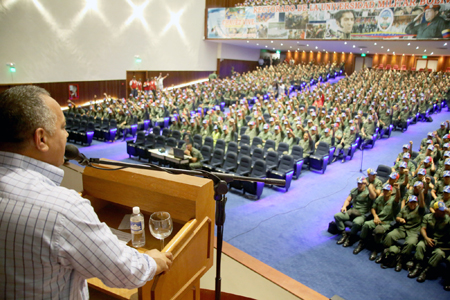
[0,85,56,147]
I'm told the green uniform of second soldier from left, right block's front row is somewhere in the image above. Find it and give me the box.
[360,194,399,244]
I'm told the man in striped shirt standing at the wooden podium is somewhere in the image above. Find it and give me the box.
[0,86,173,299]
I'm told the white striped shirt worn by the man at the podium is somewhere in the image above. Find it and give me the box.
[0,151,156,299]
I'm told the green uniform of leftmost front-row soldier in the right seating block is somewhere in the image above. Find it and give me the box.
[334,187,372,235]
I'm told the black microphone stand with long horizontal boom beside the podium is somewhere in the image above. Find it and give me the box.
[79,155,286,300]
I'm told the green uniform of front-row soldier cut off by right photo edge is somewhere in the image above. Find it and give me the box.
[414,214,450,267]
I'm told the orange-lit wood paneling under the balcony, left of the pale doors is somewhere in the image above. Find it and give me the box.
[286,51,355,75]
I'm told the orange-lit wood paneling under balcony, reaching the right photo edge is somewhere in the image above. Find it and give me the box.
[367,54,450,72]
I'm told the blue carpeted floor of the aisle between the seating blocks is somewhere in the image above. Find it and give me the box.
[67,100,450,300]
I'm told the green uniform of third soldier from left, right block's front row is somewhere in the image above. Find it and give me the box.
[384,205,425,255]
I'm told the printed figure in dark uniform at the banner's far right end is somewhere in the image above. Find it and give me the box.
[405,4,450,39]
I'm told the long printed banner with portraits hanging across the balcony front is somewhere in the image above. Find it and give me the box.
[207,0,450,39]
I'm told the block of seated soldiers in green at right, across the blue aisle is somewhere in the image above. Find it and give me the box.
[334,121,450,291]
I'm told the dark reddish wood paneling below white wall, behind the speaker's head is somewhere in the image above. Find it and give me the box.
[0,80,126,106]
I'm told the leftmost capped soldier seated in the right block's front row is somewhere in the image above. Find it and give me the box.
[334,177,376,247]
